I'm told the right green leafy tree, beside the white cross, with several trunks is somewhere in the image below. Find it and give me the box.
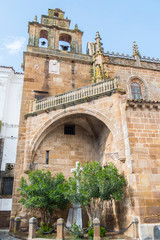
[66,162,125,223]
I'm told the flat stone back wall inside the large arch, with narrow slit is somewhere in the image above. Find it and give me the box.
[34,124,97,178]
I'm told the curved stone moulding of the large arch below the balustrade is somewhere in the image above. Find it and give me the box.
[24,107,124,170]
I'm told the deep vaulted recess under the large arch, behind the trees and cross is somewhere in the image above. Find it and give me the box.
[32,114,115,177]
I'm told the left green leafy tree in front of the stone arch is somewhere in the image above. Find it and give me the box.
[18,170,68,224]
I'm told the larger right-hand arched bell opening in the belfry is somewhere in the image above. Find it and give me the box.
[59,33,72,51]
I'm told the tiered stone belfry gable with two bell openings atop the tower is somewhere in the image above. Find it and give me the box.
[28,8,83,53]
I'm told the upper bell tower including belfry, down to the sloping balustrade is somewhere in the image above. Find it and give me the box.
[23,8,92,99]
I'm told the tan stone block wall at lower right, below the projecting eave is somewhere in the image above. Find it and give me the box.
[127,103,160,223]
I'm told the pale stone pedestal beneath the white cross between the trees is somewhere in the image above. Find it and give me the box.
[67,203,83,228]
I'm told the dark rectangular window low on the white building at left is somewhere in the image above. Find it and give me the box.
[2,177,13,195]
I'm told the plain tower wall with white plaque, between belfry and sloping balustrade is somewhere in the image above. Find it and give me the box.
[23,50,92,100]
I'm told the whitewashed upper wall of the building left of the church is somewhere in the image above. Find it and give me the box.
[0,67,24,171]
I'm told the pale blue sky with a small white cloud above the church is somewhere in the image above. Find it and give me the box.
[0,0,160,72]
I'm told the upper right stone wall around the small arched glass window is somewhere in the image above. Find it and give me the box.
[104,59,160,101]
